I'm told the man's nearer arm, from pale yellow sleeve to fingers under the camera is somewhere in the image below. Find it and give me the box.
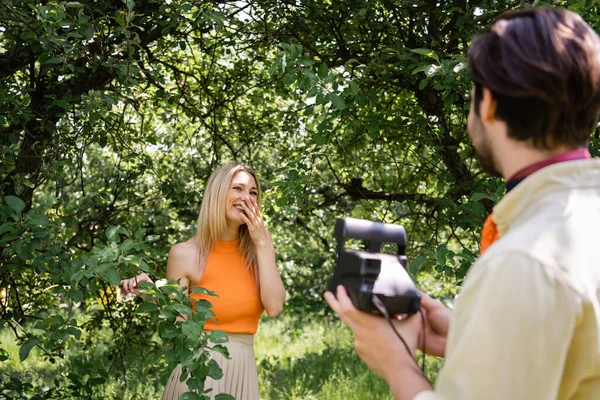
[325,254,580,400]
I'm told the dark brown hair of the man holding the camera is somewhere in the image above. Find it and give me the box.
[468,8,600,149]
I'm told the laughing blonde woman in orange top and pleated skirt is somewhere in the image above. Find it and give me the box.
[121,163,285,400]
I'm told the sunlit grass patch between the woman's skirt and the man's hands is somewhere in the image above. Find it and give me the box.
[255,316,441,400]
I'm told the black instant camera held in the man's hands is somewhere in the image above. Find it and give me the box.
[327,218,421,315]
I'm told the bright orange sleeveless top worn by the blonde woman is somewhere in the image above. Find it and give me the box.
[190,240,264,334]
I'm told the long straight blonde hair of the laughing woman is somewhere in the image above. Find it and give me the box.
[196,163,261,288]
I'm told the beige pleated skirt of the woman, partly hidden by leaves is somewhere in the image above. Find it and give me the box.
[162,333,259,400]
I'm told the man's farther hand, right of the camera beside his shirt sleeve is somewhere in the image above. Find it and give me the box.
[418,292,451,357]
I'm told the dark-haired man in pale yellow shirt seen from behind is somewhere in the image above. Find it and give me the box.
[325,8,600,400]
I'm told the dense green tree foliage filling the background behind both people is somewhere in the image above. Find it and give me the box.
[0,0,600,397]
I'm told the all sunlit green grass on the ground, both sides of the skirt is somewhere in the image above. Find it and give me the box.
[0,315,440,400]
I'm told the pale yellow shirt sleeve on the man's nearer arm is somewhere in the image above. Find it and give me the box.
[426,253,581,400]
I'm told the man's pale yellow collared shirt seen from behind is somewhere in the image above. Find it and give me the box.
[415,160,600,400]
